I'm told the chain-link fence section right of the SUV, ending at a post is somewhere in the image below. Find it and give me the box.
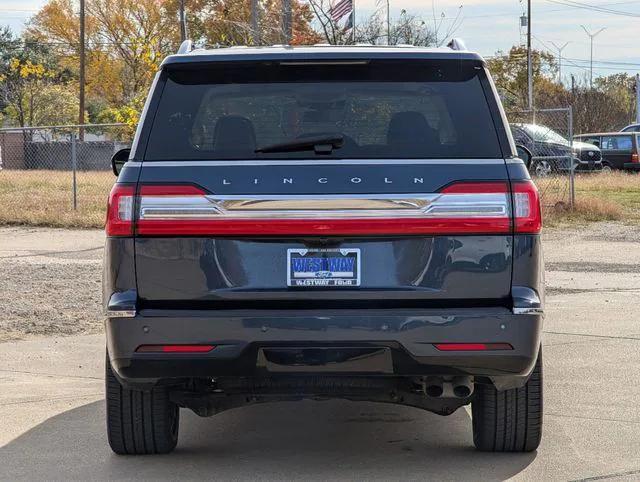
[507,108,576,207]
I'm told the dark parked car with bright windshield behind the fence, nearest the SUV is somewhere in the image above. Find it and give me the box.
[511,123,602,176]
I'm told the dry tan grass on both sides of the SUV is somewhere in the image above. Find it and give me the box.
[0,170,640,228]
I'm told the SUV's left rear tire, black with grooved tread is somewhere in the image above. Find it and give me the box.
[105,356,180,455]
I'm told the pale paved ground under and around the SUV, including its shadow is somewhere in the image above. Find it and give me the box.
[0,224,640,480]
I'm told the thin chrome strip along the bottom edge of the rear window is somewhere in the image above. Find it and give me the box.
[135,159,505,167]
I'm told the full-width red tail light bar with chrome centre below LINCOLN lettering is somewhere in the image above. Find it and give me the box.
[107,181,542,236]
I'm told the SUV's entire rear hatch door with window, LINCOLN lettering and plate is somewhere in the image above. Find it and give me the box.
[135,59,513,308]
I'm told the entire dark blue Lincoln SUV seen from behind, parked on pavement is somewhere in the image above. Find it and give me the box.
[104,46,544,454]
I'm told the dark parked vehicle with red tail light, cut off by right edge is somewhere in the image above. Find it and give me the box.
[574,132,640,171]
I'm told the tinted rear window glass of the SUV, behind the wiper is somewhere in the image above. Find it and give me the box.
[145,61,502,160]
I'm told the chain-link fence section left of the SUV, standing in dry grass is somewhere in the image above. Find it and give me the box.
[0,124,132,227]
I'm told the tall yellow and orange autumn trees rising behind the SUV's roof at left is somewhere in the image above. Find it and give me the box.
[25,0,320,122]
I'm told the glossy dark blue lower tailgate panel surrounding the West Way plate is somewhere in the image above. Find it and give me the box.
[136,236,512,301]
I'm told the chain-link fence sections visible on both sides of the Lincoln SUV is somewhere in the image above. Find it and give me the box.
[0,114,590,227]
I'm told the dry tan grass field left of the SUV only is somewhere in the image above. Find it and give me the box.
[0,170,115,228]
